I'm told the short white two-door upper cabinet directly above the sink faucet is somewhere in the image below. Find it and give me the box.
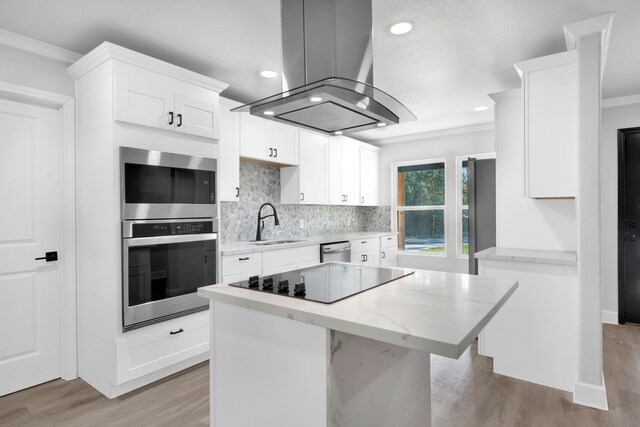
[240,113,298,165]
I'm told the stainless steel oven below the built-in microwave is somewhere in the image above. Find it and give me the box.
[122,218,218,331]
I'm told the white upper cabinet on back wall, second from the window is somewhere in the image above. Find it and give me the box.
[329,136,360,205]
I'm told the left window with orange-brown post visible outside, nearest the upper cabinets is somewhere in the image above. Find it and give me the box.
[394,159,446,255]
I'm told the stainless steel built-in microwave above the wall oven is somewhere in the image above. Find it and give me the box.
[120,147,217,220]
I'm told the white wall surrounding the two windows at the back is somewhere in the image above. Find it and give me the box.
[380,130,494,273]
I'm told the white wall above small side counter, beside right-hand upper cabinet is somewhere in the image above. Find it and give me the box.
[492,89,577,251]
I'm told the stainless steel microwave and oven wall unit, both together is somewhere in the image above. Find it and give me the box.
[120,147,218,331]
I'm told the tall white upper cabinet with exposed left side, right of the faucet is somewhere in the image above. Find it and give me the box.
[280,130,329,205]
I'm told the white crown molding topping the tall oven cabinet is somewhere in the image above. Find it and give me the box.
[67,42,229,92]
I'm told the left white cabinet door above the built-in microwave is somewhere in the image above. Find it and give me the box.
[114,74,176,129]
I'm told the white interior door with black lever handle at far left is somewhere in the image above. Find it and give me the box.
[0,99,64,396]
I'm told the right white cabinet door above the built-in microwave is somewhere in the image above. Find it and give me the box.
[175,94,220,139]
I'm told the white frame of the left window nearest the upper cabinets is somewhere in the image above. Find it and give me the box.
[391,157,449,258]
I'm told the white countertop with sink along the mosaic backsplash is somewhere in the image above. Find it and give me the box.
[220,231,397,255]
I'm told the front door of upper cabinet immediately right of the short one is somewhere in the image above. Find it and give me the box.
[298,130,328,205]
